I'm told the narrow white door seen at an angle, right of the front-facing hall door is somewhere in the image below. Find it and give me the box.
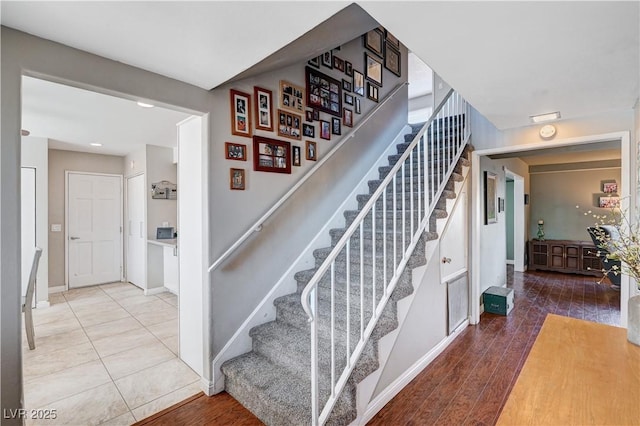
[126,175,147,288]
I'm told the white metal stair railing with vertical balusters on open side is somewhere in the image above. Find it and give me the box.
[301,90,470,425]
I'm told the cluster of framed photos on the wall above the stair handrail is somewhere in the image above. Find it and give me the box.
[218,27,407,191]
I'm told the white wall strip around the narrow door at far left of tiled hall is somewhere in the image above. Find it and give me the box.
[20,136,49,306]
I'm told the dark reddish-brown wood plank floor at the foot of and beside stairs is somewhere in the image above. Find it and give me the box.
[137,271,620,426]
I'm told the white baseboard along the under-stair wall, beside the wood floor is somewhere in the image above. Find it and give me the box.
[361,320,469,424]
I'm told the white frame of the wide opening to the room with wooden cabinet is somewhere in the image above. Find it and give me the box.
[471,131,636,328]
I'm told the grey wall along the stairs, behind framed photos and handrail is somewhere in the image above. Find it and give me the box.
[210,38,407,357]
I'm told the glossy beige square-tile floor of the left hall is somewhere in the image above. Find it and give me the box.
[22,283,200,425]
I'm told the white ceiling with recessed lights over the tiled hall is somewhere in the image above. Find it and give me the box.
[22,76,189,156]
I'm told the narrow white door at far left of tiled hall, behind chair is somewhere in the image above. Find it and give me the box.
[20,167,37,306]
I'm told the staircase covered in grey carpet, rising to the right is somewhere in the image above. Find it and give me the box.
[221,121,470,425]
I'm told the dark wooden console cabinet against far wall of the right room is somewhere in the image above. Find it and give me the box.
[529,239,602,276]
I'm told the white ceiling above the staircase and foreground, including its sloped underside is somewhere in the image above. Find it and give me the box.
[0,1,640,153]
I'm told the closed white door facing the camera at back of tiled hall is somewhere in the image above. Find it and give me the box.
[66,172,122,288]
